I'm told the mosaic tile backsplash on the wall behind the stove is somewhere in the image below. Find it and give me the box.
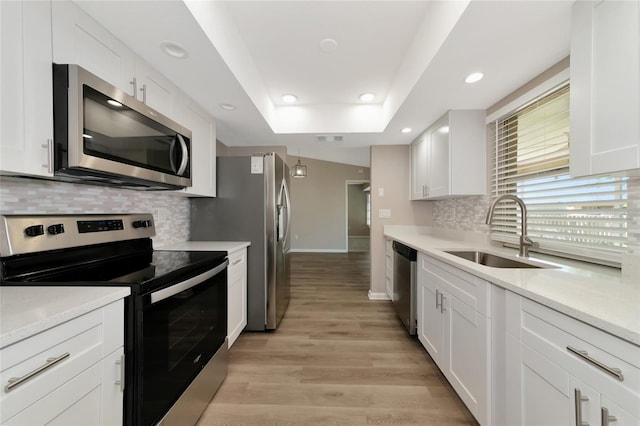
[0,177,190,246]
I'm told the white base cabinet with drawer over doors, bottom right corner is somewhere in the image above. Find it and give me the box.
[505,293,640,426]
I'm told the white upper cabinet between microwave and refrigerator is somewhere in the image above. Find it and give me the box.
[176,99,216,197]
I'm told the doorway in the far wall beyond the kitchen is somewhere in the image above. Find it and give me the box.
[345,181,371,252]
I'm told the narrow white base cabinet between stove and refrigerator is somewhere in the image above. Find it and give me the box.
[227,248,247,347]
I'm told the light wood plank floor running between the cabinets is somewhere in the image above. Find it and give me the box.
[198,253,476,426]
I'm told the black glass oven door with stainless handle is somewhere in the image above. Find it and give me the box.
[133,260,228,425]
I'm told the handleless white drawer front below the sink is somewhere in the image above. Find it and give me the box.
[419,254,491,318]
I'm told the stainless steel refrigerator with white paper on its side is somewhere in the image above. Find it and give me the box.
[191,153,291,331]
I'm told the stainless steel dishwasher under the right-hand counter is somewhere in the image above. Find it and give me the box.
[393,241,418,335]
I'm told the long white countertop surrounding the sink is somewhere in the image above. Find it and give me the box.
[384,226,640,346]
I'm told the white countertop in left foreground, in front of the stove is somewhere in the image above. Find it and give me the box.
[0,286,131,348]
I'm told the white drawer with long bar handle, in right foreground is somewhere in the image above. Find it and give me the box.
[520,299,640,402]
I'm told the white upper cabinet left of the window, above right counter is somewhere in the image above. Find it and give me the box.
[411,110,487,200]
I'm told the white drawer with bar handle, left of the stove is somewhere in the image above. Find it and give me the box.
[0,309,104,423]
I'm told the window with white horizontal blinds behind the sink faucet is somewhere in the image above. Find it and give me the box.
[489,84,628,264]
